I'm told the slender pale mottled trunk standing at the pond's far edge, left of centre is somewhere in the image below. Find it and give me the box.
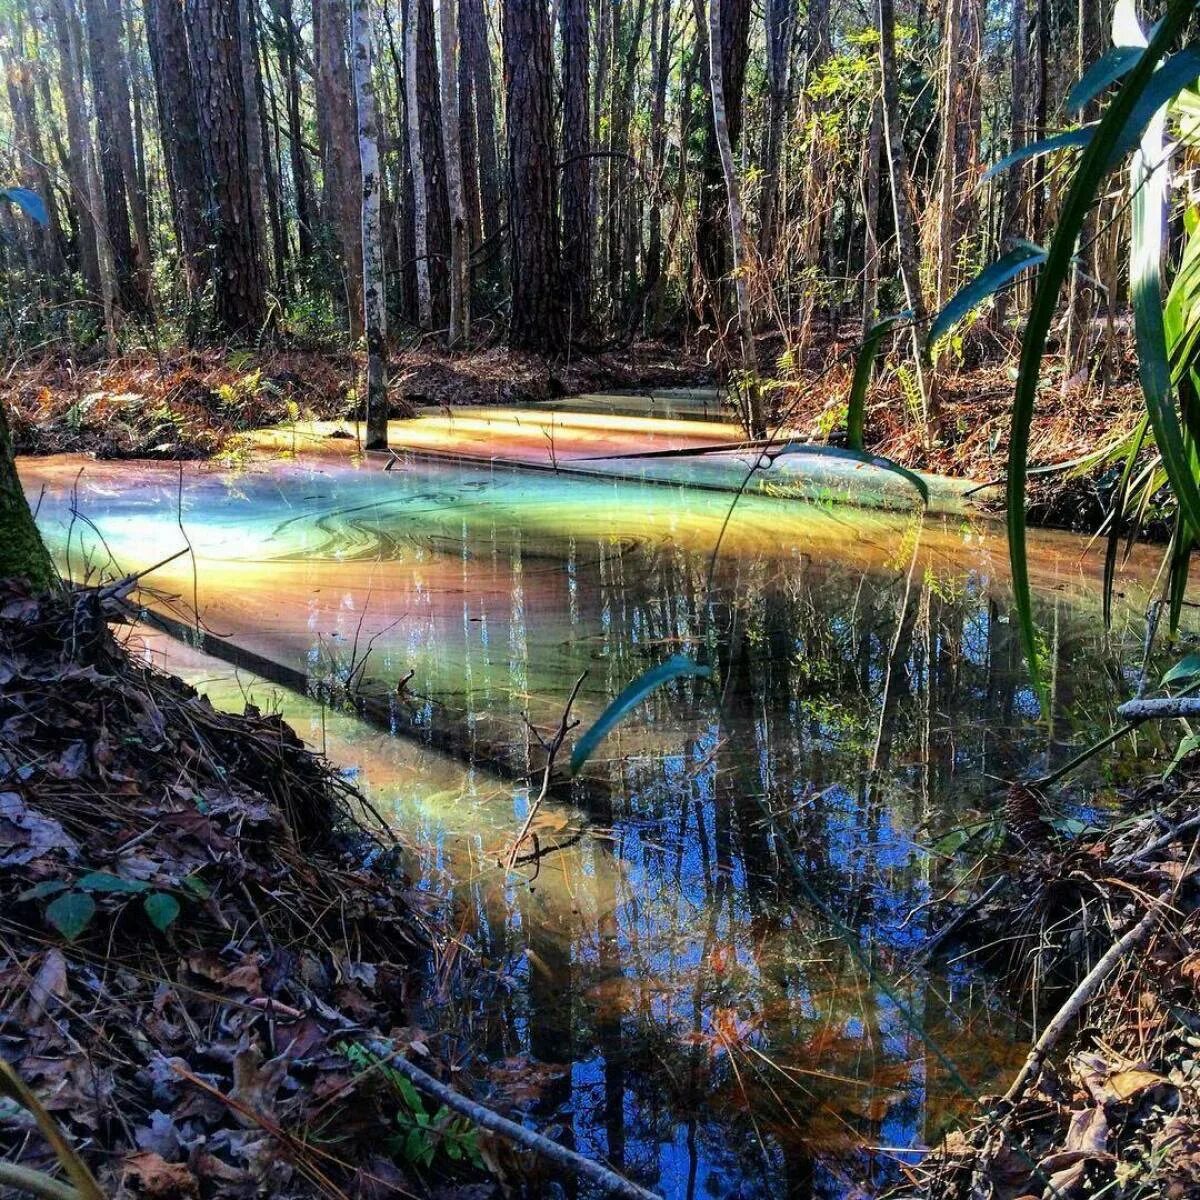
[352,0,388,450]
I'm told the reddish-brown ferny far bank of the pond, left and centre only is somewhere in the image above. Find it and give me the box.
[0,343,707,458]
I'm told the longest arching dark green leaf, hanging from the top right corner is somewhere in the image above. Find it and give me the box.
[1008,0,1194,701]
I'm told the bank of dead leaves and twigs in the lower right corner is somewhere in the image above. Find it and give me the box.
[888,764,1200,1200]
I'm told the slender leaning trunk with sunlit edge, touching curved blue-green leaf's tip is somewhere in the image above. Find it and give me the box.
[878,0,937,442]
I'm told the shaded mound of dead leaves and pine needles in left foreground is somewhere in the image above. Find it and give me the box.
[0,582,489,1198]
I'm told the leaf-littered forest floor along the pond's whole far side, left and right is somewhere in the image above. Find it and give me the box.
[0,336,1140,530]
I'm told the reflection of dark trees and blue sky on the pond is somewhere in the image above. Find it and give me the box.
[436,548,1137,1196]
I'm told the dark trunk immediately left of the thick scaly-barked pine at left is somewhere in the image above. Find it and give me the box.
[145,0,210,298]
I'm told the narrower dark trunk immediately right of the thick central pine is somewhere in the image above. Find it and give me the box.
[560,0,592,337]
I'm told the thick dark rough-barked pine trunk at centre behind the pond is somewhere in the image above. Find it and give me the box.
[504,0,564,353]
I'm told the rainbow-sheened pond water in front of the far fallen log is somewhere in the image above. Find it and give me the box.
[20,406,1190,1198]
